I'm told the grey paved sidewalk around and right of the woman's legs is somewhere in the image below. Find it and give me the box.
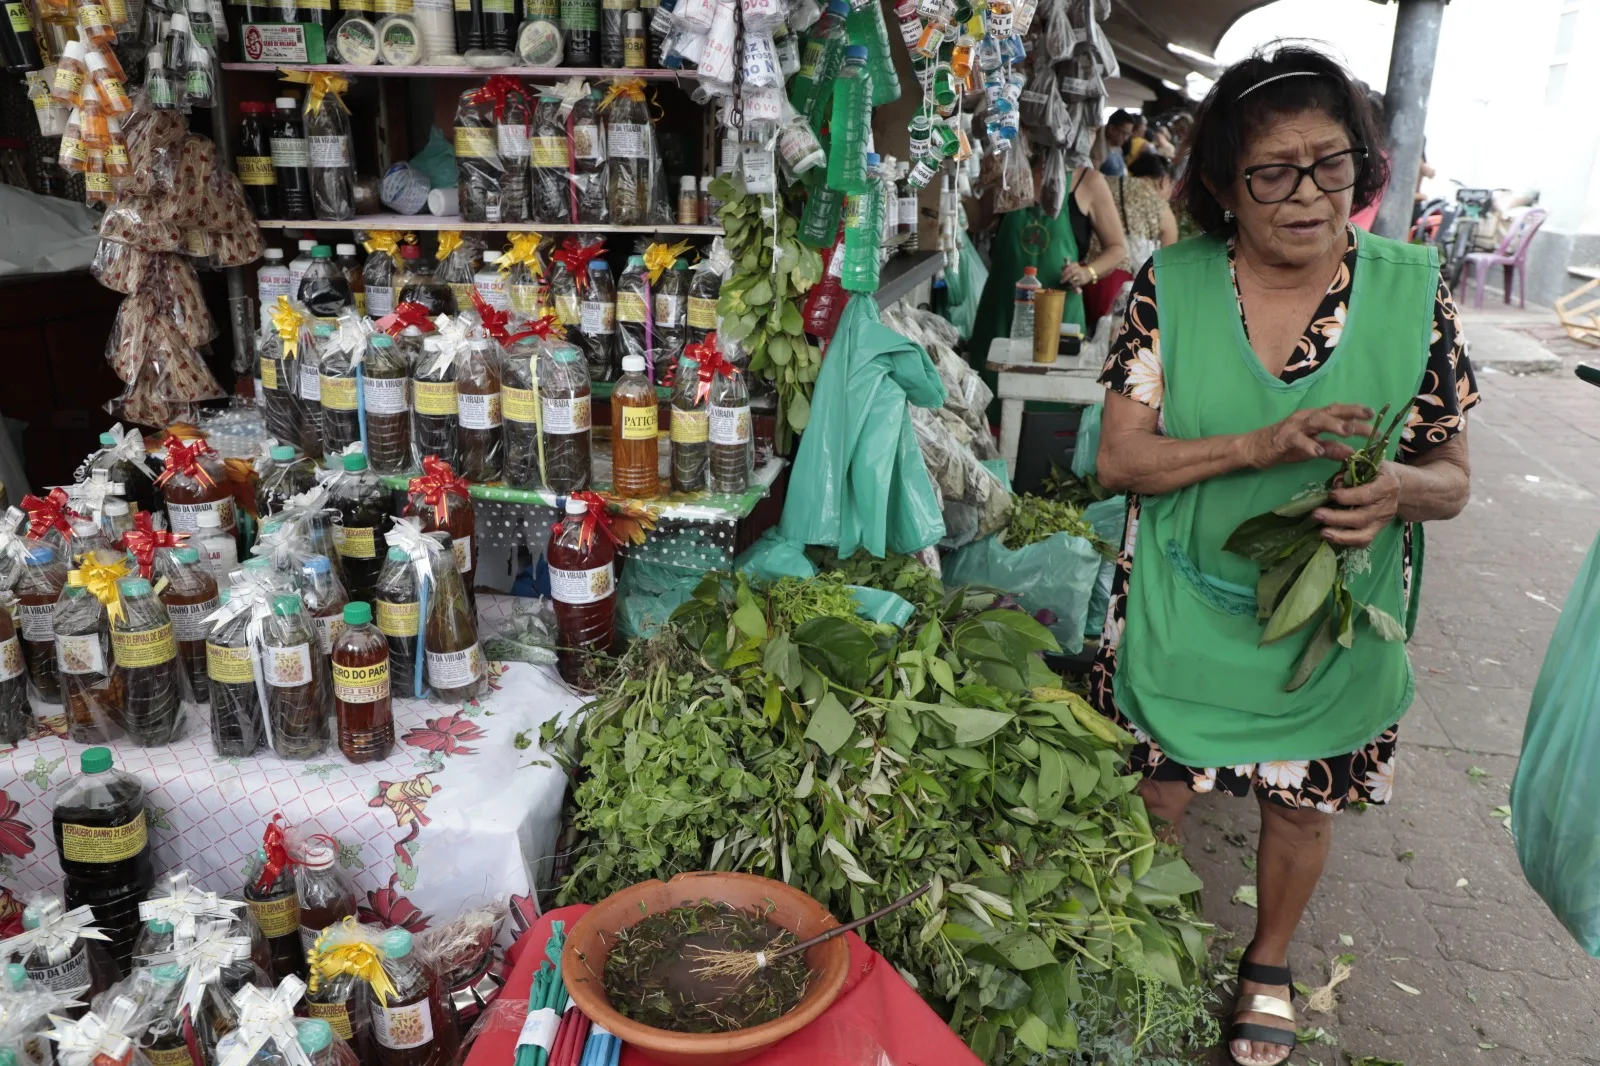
[1186,309,1600,1066]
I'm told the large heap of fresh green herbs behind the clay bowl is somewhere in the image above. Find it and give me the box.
[542,563,1216,1066]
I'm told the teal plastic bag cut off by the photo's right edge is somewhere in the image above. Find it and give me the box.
[1510,539,1600,959]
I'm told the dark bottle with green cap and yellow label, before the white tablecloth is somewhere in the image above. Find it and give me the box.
[51,742,155,970]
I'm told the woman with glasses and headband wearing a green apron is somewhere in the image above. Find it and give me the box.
[1091,46,1478,1066]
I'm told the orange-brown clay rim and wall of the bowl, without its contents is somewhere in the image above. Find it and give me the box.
[562,872,850,1066]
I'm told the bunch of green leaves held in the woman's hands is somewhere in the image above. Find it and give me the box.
[1222,407,1406,691]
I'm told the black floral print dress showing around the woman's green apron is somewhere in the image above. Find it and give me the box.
[1090,229,1478,813]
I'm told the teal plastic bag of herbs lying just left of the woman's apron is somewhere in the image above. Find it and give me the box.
[944,533,1101,655]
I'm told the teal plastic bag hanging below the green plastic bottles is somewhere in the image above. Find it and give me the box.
[778,295,946,559]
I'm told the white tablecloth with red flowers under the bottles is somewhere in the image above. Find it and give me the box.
[0,595,582,935]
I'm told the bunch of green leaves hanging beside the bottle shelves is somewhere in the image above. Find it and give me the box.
[710,174,822,451]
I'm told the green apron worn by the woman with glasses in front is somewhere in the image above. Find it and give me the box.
[1115,230,1438,767]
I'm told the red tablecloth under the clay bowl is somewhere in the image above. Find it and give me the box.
[466,906,979,1066]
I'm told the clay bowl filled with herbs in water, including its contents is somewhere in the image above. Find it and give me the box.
[562,872,850,1066]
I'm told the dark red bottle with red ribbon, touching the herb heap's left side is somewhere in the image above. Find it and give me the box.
[544,498,616,685]
